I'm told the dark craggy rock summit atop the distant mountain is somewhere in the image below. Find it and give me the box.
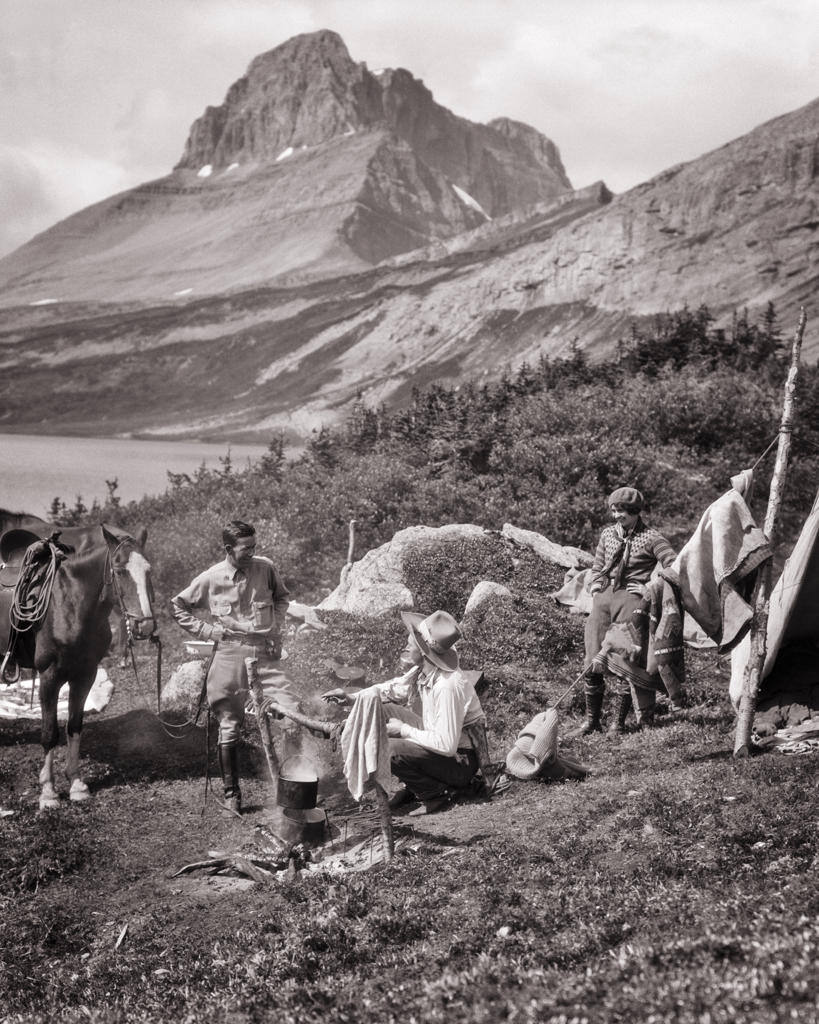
[176,29,571,216]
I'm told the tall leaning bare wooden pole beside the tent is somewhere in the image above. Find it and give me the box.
[734,306,807,758]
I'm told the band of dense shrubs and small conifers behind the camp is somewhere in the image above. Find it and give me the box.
[53,308,819,601]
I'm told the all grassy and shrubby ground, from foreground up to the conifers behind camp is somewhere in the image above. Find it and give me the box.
[0,310,819,1024]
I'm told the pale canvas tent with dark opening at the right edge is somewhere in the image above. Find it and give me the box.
[730,494,819,727]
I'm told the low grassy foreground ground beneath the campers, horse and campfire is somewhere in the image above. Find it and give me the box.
[0,622,819,1024]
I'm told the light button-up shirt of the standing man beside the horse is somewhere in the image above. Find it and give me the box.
[171,555,290,640]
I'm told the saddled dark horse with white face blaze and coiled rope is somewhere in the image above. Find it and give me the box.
[0,524,157,810]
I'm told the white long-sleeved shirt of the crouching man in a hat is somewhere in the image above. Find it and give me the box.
[374,668,484,758]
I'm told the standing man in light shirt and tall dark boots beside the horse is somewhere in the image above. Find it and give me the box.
[171,519,296,817]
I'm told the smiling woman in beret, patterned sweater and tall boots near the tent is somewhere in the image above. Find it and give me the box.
[576,487,677,735]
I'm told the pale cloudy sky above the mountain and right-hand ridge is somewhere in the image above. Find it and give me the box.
[0,0,819,255]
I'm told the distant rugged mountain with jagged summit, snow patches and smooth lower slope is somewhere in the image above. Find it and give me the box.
[0,32,571,306]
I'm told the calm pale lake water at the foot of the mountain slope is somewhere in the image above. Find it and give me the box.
[0,434,266,516]
